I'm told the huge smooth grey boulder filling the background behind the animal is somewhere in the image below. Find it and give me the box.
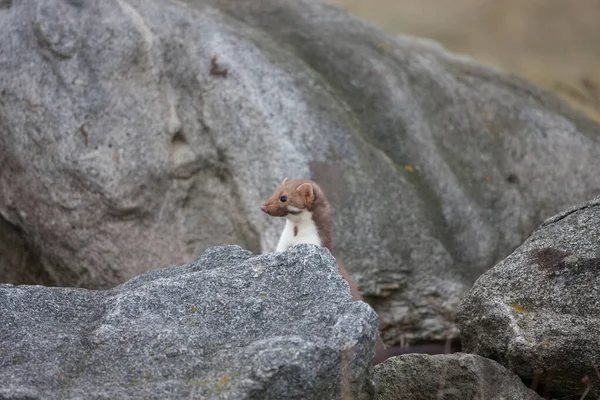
[0,0,600,344]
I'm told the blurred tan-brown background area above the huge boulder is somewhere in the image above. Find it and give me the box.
[333,0,600,122]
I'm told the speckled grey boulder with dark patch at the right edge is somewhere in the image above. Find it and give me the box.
[458,198,600,398]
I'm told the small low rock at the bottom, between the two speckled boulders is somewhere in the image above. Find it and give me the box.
[375,353,541,400]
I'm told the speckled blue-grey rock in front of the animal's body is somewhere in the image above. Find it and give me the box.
[0,245,377,400]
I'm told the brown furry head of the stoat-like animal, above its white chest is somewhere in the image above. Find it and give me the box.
[260,178,316,217]
